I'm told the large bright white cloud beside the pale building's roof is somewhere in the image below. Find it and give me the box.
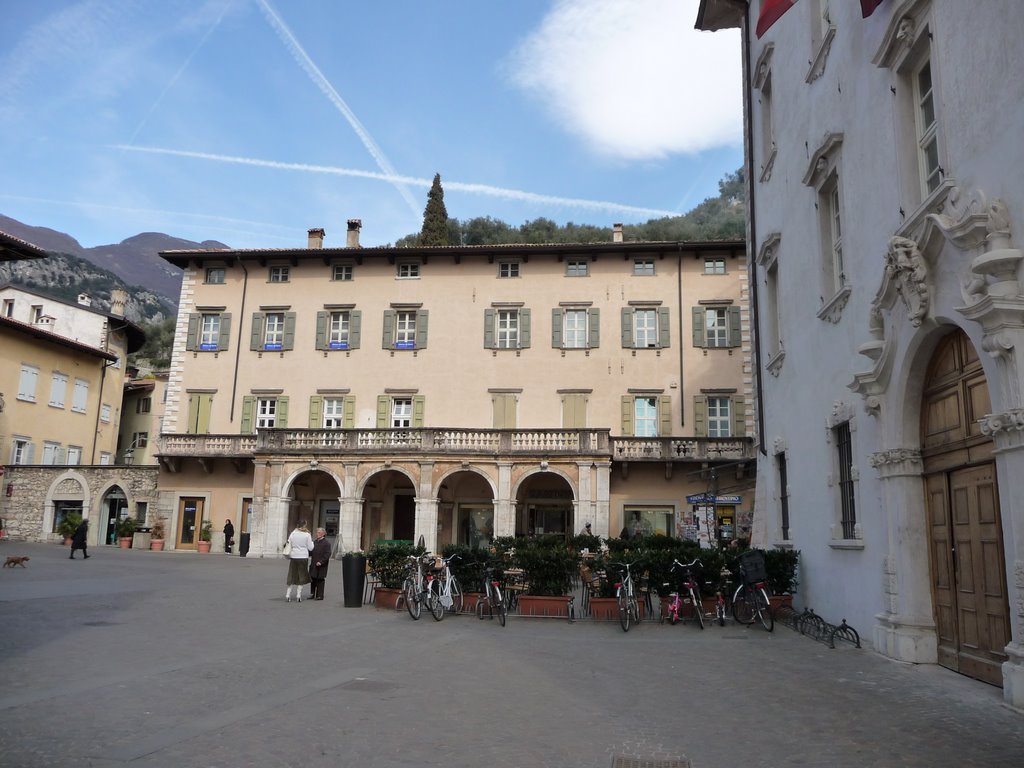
[508,0,742,160]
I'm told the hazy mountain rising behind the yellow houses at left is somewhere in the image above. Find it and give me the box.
[0,214,228,308]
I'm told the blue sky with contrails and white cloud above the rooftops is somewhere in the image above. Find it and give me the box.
[0,0,742,248]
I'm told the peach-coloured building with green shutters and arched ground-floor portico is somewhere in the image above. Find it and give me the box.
[158,225,754,554]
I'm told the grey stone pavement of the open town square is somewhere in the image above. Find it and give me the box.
[0,543,1024,768]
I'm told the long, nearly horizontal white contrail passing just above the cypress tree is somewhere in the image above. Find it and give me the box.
[113,144,680,217]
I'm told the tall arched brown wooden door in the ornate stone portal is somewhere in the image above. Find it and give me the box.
[922,331,1010,685]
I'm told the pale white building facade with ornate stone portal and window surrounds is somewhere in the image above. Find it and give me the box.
[697,0,1024,707]
